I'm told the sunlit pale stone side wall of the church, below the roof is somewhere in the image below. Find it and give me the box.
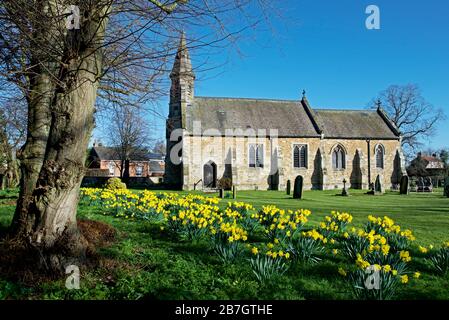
[183,136,400,190]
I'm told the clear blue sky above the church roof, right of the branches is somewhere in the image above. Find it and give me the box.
[145,0,449,148]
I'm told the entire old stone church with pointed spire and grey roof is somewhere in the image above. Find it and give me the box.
[165,35,406,190]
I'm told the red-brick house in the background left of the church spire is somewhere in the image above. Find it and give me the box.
[86,143,165,183]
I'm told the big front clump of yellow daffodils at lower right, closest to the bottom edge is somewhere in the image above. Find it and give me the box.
[338,216,420,300]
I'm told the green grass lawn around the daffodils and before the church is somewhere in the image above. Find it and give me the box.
[0,190,449,299]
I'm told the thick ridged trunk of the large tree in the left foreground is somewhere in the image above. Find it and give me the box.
[13,3,109,271]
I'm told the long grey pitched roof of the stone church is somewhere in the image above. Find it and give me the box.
[186,97,400,139]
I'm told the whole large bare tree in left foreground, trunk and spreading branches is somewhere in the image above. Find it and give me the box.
[0,0,274,271]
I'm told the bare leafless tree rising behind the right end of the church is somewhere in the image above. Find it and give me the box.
[371,84,444,155]
